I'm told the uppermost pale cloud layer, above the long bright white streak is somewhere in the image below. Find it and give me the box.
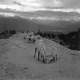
[0,0,80,8]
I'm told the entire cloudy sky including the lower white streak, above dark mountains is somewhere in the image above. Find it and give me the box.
[0,0,80,32]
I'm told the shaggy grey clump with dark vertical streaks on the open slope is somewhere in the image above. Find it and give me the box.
[34,40,57,63]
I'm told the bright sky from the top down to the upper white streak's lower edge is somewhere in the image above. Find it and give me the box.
[0,0,80,12]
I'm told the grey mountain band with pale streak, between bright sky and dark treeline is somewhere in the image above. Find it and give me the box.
[0,11,80,33]
